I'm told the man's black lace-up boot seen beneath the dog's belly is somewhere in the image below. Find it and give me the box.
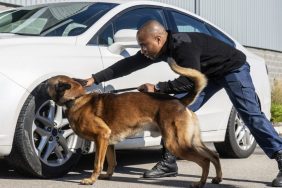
[143,146,178,178]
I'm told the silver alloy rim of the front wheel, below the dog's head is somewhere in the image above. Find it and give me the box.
[32,100,78,166]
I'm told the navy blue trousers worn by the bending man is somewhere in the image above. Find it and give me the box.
[178,63,282,158]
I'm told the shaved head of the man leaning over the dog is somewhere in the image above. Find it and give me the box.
[137,20,168,59]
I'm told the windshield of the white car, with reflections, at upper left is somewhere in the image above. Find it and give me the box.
[0,2,116,36]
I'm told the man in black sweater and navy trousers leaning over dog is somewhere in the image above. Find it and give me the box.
[78,21,282,186]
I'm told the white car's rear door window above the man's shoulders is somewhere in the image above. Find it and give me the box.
[171,11,210,35]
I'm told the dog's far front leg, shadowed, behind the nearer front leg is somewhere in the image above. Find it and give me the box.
[99,145,117,179]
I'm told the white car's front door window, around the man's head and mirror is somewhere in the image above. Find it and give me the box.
[94,8,166,45]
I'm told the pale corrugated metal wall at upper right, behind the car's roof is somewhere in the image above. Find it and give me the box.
[199,0,282,52]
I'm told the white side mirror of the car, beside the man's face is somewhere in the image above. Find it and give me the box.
[108,29,139,55]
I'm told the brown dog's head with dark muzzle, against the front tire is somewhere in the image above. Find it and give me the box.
[47,75,85,106]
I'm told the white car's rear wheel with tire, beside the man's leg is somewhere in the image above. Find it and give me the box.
[214,108,257,158]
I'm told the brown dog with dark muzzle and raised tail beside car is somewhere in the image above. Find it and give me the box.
[47,63,222,187]
